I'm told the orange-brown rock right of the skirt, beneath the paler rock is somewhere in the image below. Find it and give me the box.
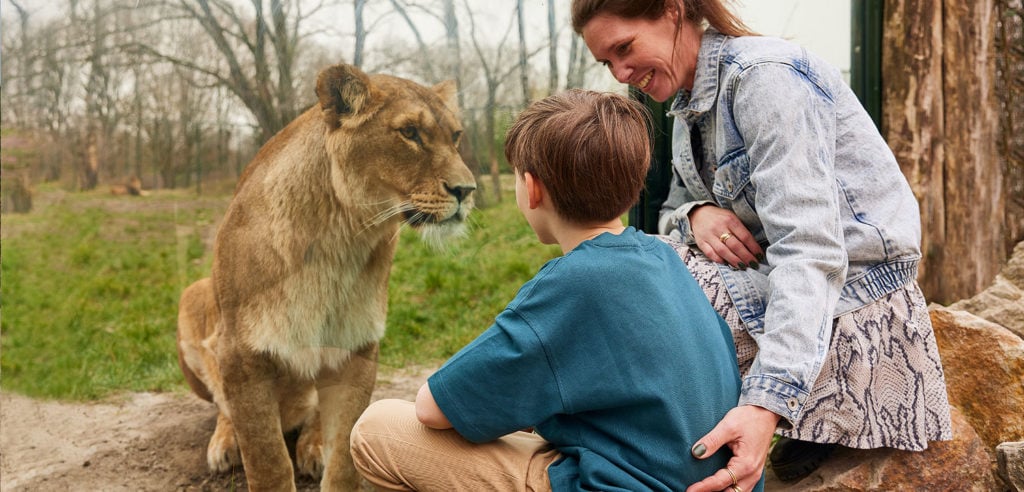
[930,304,1024,452]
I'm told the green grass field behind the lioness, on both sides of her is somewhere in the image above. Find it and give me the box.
[0,178,558,400]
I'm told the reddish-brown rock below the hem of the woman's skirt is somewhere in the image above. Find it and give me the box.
[765,408,997,492]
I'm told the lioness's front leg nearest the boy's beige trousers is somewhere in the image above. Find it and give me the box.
[316,342,378,491]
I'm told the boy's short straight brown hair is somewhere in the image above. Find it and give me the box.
[505,89,650,223]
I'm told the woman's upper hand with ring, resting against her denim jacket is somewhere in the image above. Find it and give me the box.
[689,205,764,270]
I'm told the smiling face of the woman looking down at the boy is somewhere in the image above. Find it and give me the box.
[583,9,700,101]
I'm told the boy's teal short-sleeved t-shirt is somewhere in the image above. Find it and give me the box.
[429,228,761,491]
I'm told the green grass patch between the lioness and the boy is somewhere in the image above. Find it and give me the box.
[381,184,560,367]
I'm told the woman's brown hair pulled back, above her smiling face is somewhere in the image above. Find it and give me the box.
[571,0,757,36]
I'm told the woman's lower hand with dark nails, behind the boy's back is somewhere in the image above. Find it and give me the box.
[686,405,780,492]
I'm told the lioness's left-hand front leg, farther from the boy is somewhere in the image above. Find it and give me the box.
[221,353,295,491]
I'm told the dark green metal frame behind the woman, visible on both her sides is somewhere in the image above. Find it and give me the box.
[629,0,884,234]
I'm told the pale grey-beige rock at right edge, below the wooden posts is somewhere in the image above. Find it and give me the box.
[948,242,1024,338]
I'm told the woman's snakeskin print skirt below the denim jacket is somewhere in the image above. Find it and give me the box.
[662,237,952,451]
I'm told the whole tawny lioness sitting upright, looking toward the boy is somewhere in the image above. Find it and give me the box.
[178,66,475,491]
